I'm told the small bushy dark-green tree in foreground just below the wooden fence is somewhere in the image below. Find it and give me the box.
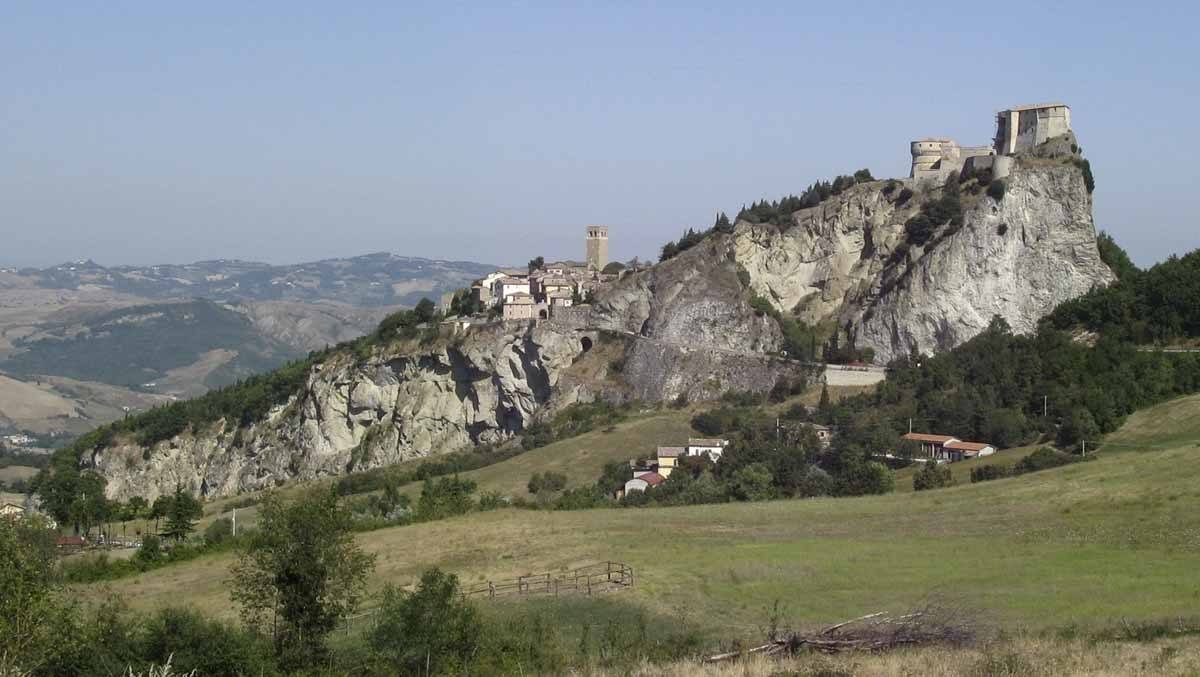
[371,569,484,675]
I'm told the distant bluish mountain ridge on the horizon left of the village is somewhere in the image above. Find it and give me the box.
[8,252,498,307]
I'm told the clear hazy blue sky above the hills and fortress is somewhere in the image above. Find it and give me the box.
[0,0,1200,265]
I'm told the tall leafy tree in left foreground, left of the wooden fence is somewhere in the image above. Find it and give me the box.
[230,487,374,670]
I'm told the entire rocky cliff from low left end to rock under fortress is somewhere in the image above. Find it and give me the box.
[88,151,1112,499]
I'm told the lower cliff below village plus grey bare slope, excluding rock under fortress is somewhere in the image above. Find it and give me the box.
[96,240,804,499]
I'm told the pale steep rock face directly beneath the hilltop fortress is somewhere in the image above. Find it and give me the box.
[733,161,1114,363]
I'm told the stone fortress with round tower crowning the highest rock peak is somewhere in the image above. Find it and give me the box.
[908,103,1070,182]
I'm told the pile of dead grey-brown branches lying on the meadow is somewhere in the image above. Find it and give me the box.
[704,605,978,663]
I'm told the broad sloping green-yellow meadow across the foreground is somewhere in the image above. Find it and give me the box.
[96,397,1200,637]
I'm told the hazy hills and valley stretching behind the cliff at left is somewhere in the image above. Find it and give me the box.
[0,253,490,442]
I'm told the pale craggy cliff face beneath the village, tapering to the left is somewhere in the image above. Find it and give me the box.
[92,323,583,499]
